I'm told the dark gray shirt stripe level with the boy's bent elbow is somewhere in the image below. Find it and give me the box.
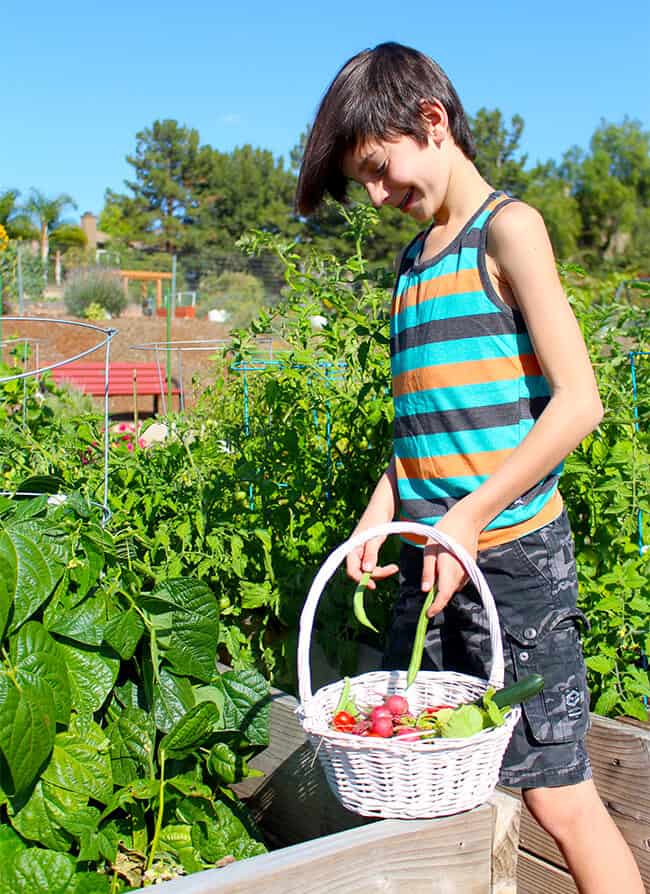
[394,397,549,438]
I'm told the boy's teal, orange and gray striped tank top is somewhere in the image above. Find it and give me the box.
[390,192,562,549]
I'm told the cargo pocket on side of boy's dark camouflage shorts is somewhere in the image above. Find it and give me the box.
[505,609,589,745]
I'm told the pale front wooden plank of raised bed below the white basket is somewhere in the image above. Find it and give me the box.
[156,805,494,894]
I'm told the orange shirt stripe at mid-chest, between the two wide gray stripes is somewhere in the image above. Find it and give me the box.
[393,354,542,397]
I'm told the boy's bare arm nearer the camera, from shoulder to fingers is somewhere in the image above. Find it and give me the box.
[422,203,603,615]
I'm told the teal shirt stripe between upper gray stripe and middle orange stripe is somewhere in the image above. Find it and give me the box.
[391,333,533,376]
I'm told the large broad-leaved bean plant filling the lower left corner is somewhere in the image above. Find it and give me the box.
[0,494,268,892]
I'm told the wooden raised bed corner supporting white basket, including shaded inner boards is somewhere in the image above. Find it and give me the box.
[157,691,520,894]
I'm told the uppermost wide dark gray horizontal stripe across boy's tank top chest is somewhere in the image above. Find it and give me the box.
[390,311,526,355]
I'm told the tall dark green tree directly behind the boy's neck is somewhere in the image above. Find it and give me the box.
[470,108,528,196]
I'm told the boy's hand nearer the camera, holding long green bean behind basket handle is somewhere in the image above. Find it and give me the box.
[422,503,479,618]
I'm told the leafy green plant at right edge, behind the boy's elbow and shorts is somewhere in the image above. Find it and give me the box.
[561,271,650,720]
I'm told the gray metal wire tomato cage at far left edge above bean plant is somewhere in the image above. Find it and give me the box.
[0,316,117,524]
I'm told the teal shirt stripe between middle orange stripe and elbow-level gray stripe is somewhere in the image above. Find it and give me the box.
[393,376,550,417]
